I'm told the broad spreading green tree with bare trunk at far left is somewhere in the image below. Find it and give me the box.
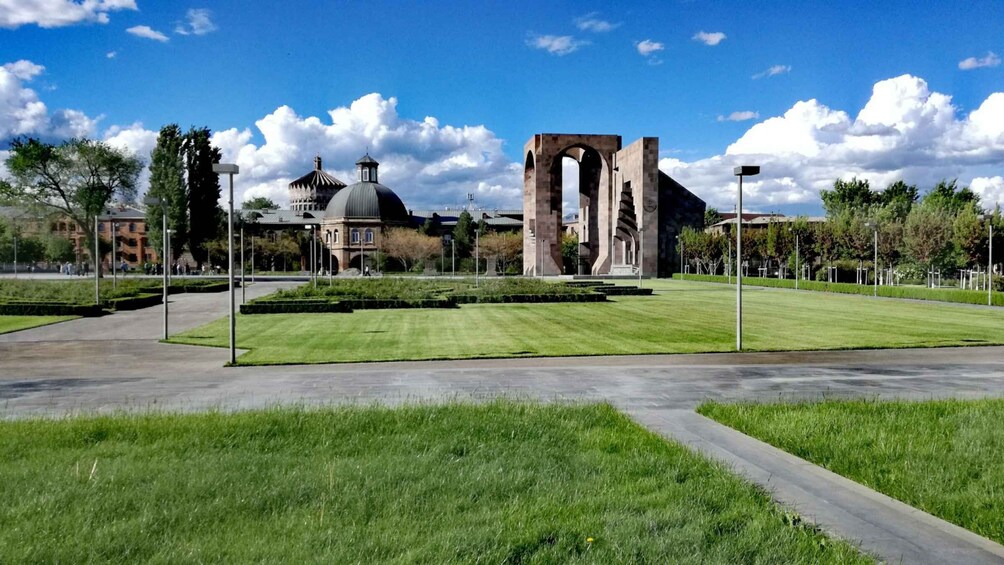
[0,137,143,263]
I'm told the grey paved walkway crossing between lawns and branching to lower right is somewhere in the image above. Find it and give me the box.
[0,283,1004,563]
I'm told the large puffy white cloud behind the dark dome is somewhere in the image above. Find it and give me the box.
[199,92,522,210]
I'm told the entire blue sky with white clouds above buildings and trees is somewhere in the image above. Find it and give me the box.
[0,0,1004,214]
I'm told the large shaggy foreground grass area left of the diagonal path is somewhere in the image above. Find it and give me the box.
[0,400,870,563]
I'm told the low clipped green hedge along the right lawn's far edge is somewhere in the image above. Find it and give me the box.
[673,273,1004,306]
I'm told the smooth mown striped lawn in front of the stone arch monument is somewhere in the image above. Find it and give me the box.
[171,280,1004,364]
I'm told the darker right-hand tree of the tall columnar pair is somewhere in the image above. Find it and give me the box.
[185,127,223,266]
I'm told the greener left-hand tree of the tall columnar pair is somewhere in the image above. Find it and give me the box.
[147,123,189,260]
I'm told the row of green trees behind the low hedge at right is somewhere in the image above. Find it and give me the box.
[678,179,1004,284]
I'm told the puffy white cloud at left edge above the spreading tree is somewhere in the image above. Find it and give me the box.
[0,59,99,142]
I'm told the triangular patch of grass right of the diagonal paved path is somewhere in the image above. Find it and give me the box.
[698,398,1004,543]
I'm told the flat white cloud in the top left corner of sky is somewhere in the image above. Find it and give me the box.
[0,0,137,29]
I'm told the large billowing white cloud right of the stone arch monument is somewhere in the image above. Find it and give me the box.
[660,74,1004,210]
